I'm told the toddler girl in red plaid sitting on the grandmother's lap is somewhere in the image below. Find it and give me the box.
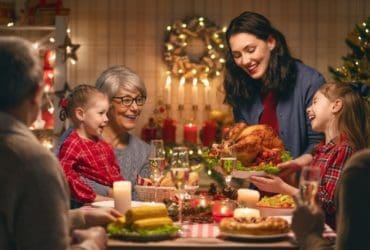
[58,85,123,203]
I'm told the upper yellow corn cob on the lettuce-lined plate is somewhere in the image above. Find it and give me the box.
[125,204,168,224]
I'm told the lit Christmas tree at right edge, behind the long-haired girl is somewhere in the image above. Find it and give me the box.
[329,17,370,87]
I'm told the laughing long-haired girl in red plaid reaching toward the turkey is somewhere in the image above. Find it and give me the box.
[250,83,368,228]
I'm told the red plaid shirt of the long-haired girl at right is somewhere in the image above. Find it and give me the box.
[312,136,356,228]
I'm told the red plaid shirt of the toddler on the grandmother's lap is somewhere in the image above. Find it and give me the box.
[59,130,123,203]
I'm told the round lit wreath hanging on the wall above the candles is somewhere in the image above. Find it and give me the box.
[164,17,226,80]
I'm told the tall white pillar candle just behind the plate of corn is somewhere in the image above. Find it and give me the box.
[113,181,131,214]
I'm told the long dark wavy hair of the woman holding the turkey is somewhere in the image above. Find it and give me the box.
[224,11,297,106]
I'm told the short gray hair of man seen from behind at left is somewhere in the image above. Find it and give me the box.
[0,37,42,111]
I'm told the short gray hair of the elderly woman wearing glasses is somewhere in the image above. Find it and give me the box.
[95,65,146,99]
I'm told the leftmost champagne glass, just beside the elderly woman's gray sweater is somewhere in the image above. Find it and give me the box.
[148,139,166,201]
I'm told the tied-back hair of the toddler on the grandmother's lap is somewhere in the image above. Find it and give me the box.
[59,84,106,121]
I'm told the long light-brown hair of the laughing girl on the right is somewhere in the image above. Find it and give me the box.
[318,82,369,150]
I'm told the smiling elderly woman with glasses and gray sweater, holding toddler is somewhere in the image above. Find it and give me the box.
[57,66,150,202]
